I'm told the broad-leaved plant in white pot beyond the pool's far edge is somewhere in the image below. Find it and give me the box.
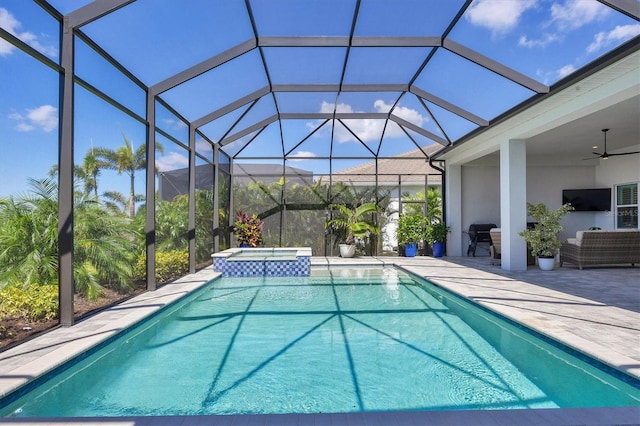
[325,203,380,257]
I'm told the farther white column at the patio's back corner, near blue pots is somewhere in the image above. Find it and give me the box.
[444,164,464,256]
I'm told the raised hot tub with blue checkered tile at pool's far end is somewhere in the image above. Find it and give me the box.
[211,247,311,277]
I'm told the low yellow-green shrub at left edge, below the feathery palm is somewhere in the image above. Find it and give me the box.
[0,284,58,321]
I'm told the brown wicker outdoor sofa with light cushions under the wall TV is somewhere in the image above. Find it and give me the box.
[560,229,640,269]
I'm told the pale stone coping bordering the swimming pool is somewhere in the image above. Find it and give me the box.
[0,257,640,425]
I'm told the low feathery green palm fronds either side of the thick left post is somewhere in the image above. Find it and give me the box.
[0,179,134,299]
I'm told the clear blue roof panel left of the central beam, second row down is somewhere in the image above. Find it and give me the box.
[263,47,347,84]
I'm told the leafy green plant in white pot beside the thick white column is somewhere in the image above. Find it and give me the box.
[518,203,573,271]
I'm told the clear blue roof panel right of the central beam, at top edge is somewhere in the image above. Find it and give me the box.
[355,0,464,36]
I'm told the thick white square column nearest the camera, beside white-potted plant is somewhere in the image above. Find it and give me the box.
[500,140,527,271]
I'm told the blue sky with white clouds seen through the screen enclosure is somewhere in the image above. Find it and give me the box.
[0,0,640,200]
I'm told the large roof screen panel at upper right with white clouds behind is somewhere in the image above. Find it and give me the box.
[449,1,640,85]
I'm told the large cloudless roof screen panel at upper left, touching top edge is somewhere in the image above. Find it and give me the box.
[82,0,254,85]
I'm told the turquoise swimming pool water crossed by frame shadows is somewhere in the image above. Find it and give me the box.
[0,268,640,417]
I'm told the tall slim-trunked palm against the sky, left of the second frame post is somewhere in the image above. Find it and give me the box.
[95,133,164,218]
